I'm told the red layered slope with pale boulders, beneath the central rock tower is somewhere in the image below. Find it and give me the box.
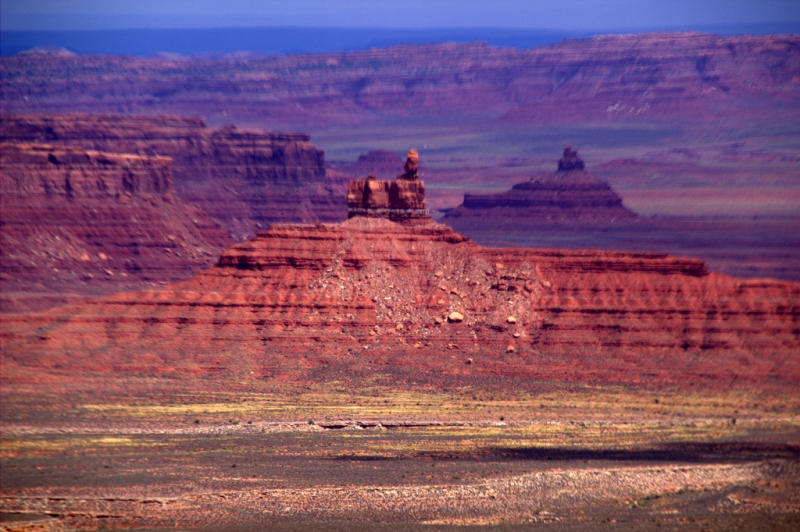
[2,217,800,388]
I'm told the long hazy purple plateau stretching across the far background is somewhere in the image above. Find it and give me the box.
[0,33,800,128]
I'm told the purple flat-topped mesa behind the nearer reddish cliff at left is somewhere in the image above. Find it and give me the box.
[0,115,346,239]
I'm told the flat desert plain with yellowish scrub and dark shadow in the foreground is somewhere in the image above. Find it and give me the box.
[0,379,800,530]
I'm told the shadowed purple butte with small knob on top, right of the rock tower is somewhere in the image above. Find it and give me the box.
[443,146,639,227]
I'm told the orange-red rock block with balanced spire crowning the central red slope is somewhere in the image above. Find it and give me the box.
[347,149,430,222]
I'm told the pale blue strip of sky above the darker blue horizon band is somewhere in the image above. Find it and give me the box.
[0,0,800,31]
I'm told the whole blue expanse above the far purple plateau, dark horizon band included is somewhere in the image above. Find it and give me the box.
[0,0,800,56]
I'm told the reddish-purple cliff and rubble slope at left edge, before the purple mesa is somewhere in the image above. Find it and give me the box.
[0,144,231,312]
